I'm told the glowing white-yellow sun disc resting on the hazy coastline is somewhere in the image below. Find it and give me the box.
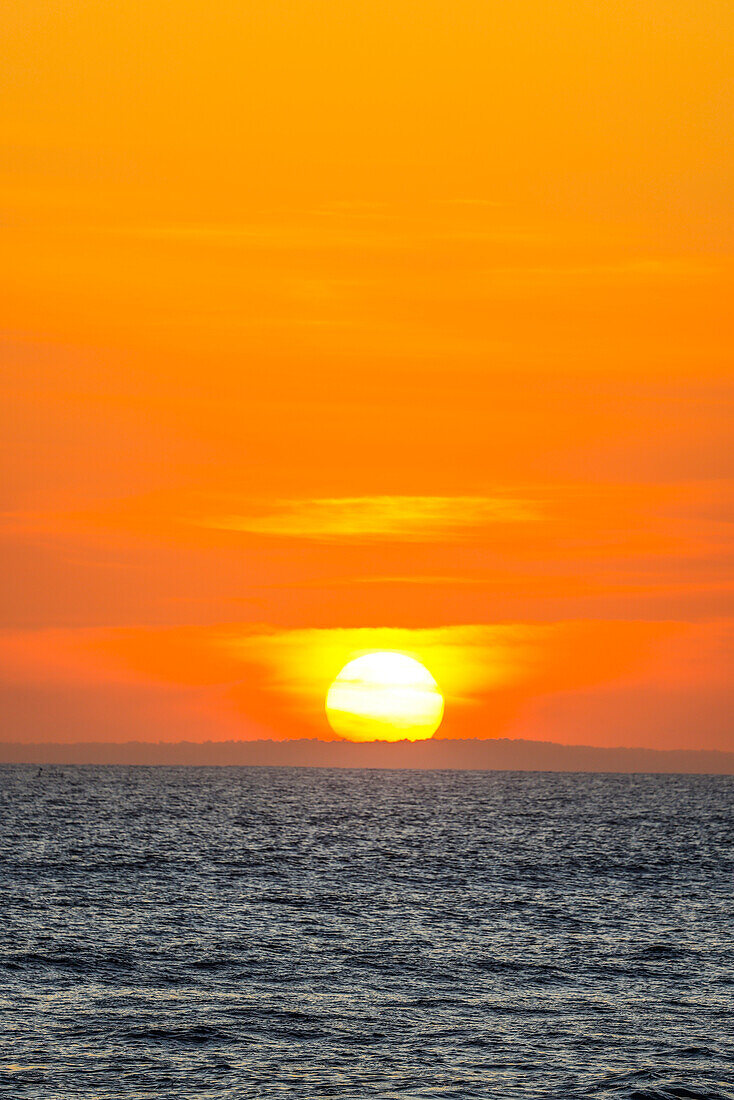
[326,650,443,741]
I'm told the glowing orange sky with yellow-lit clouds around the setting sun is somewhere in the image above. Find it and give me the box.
[0,0,734,749]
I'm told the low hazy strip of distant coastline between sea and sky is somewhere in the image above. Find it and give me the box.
[0,738,734,776]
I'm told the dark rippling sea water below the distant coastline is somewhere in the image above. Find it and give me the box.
[0,766,734,1100]
